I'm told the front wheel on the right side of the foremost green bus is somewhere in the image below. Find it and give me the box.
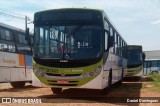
[100,70,112,95]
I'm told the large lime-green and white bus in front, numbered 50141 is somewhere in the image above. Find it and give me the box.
[27,8,127,94]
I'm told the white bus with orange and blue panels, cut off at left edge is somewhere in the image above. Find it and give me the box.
[0,23,32,88]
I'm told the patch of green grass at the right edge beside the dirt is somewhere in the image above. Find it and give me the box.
[149,73,160,92]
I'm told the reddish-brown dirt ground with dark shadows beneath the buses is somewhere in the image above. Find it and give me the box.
[0,76,160,106]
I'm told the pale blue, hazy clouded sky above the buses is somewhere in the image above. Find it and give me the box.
[0,0,160,51]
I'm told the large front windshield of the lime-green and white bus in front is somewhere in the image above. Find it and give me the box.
[34,25,102,59]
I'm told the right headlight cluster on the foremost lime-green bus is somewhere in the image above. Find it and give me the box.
[83,66,102,78]
